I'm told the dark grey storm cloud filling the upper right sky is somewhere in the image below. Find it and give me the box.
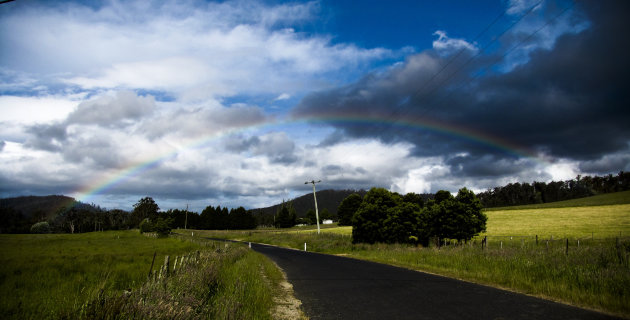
[293,1,630,174]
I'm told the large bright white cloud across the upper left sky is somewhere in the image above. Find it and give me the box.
[0,1,391,100]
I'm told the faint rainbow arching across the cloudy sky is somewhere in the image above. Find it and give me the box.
[74,114,546,203]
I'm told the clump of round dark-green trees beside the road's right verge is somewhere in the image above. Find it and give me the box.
[337,188,488,246]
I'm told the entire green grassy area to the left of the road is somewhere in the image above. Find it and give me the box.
[0,231,281,319]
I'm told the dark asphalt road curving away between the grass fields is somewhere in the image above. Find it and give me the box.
[252,243,615,320]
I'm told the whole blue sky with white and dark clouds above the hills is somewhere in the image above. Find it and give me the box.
[0,0,630,211]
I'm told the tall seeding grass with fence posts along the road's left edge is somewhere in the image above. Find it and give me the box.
[80,243,278,319]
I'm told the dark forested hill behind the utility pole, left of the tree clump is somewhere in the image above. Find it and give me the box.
[251,190,367,217]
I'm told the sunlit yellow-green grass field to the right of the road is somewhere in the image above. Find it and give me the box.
[195,192,630,318]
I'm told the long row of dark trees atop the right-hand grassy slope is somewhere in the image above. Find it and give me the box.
[477,171,630,208]
